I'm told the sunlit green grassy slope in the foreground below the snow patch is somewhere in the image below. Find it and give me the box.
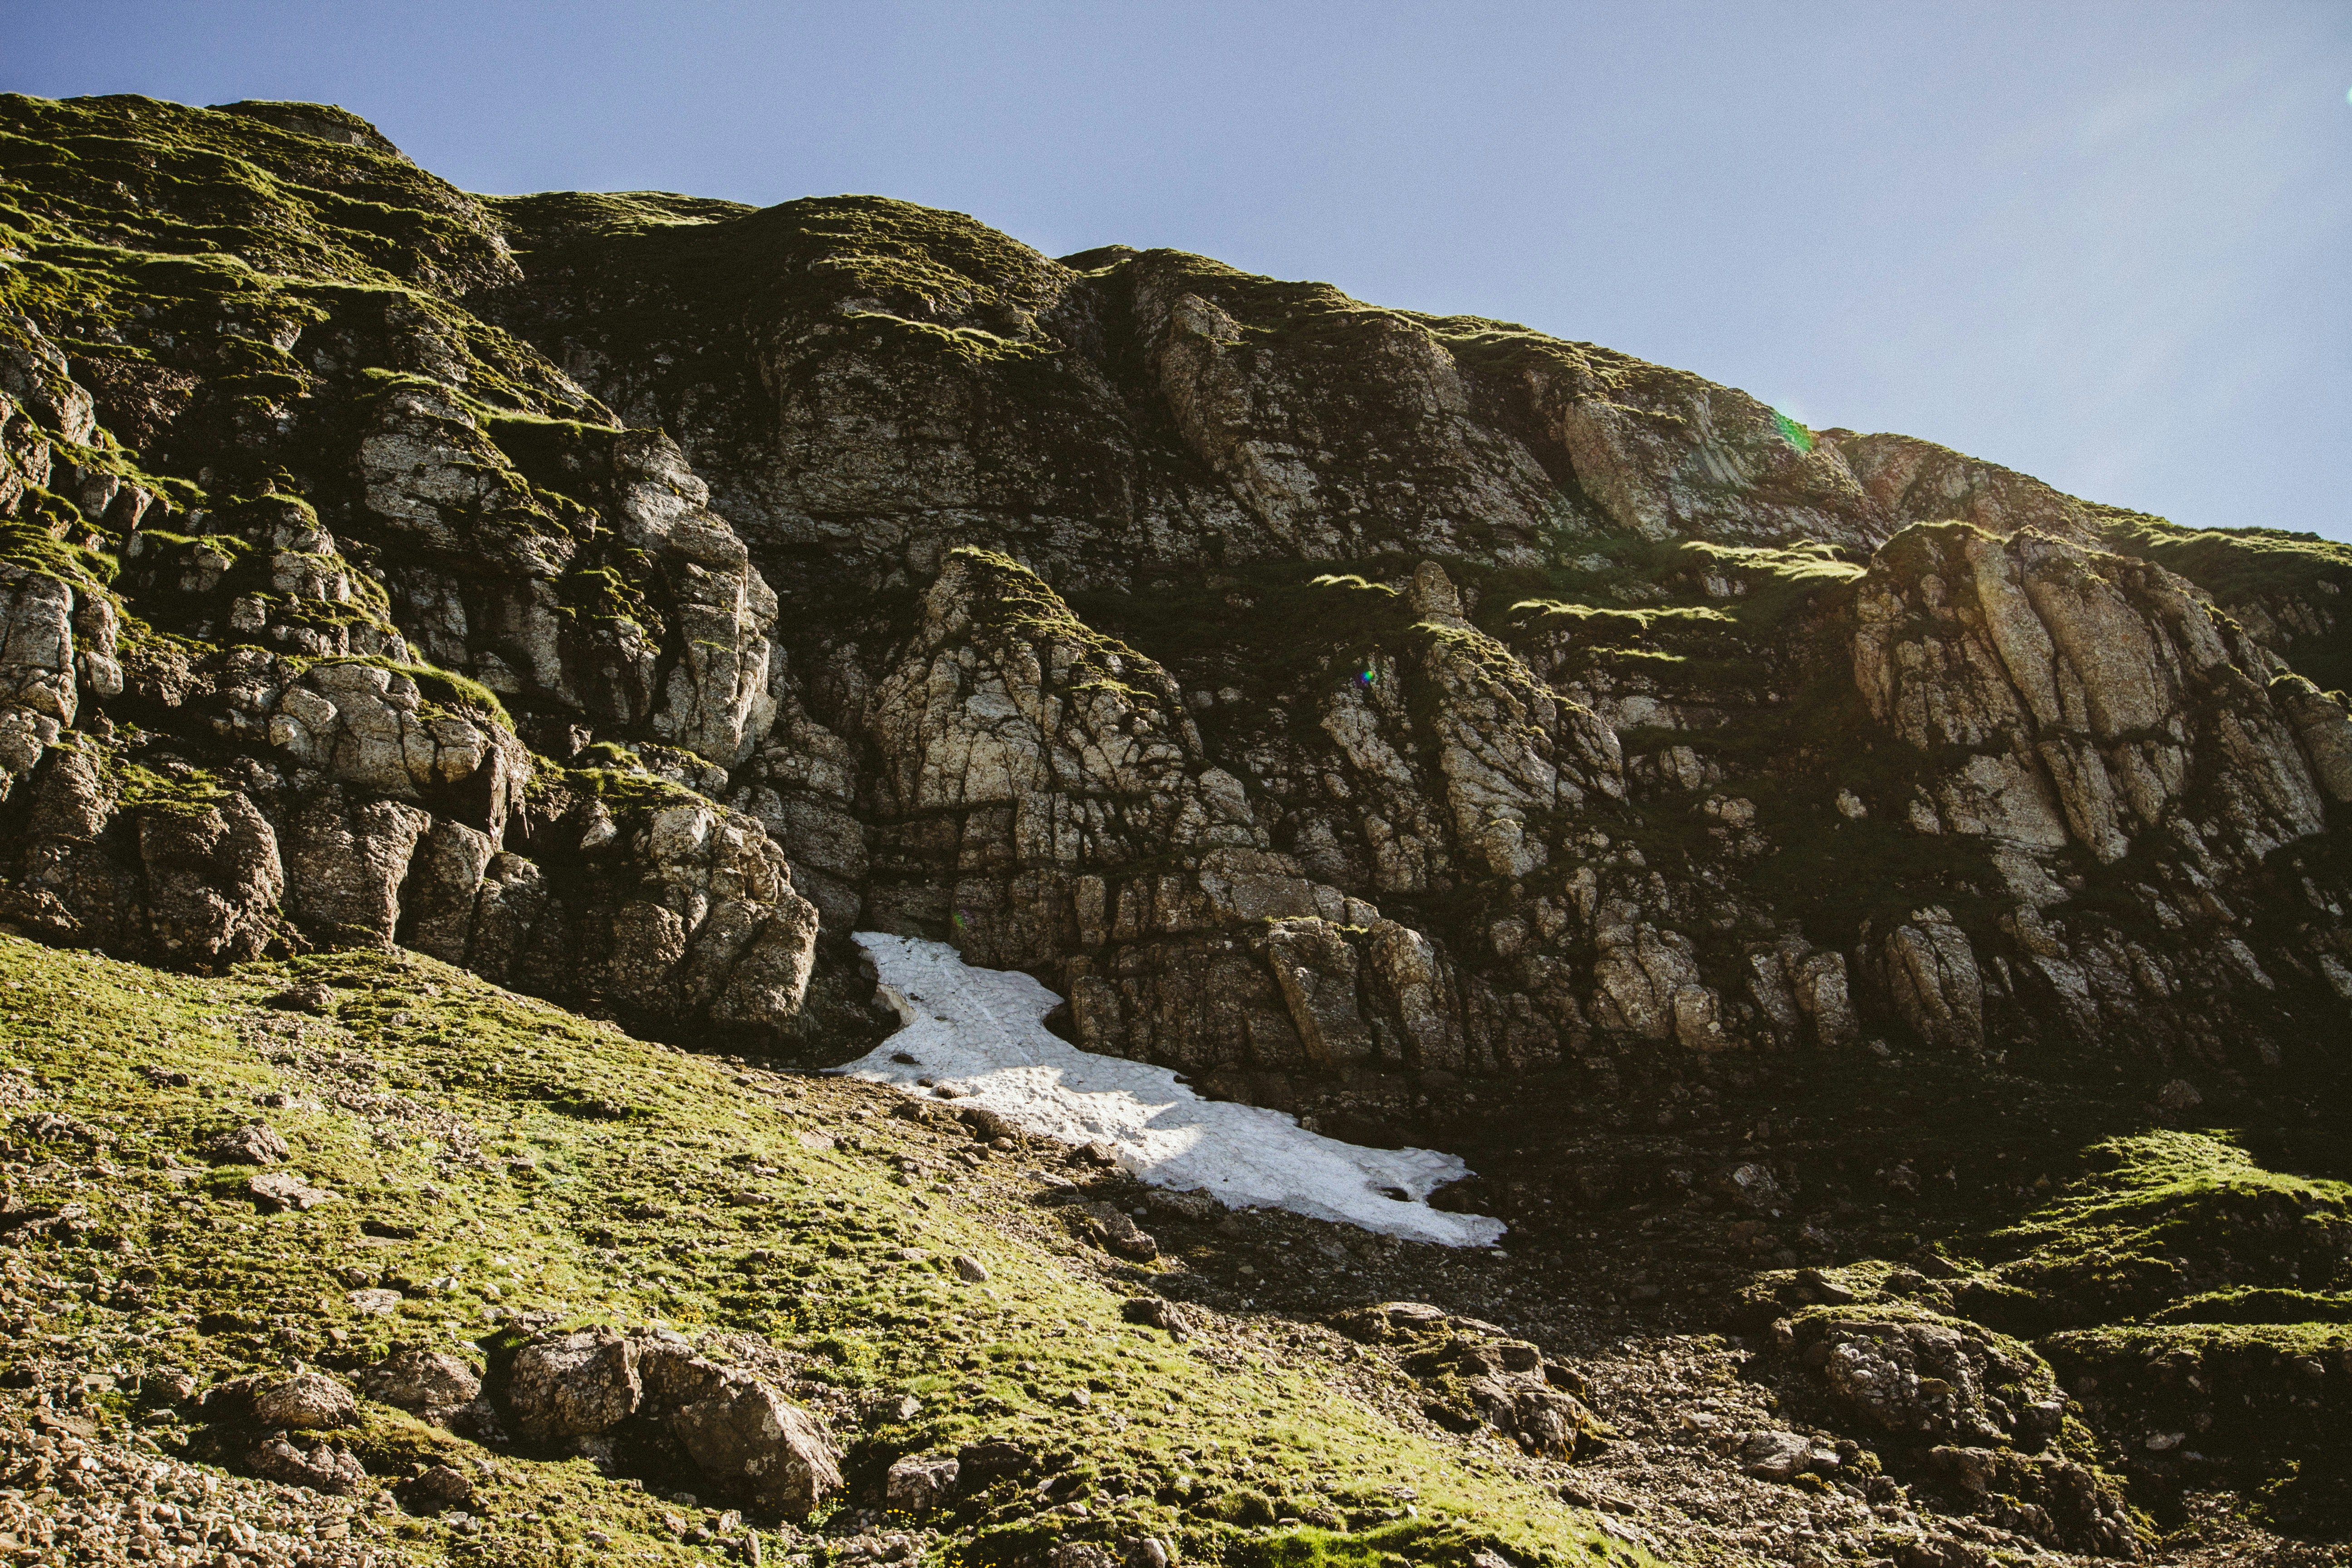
[0,938,1639,1563]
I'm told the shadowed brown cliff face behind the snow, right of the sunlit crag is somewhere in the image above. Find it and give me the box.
[468,169,2347,1110]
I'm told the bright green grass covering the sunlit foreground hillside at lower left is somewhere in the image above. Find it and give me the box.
[0,938,1630,1563]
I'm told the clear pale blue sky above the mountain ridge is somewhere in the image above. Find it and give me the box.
[14,0,2352,539]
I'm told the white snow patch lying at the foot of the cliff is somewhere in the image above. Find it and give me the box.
[847,931,1503,1246]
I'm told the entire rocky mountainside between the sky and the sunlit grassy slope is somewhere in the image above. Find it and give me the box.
[0,96,2352,1568]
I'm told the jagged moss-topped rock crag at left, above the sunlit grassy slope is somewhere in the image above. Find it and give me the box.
[0,101,847,1041]
